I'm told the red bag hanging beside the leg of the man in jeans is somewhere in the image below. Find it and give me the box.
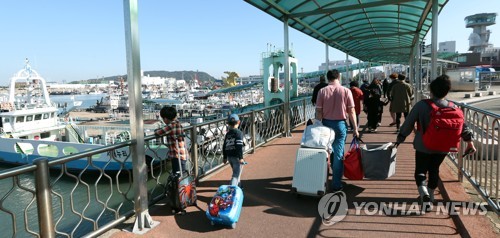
[343,137,364,180]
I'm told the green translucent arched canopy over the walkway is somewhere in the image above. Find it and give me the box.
[245,0,448,64]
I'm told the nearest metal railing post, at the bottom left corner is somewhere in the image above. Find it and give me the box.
[34,158,56,238]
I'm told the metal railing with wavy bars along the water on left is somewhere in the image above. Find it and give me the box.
[0,97,314,237]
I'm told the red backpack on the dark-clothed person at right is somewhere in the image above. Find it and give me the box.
[422,99,464,152]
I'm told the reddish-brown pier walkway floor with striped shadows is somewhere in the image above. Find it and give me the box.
[107,91,500,238]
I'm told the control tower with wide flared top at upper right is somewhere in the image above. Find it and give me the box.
[464,13,497,53]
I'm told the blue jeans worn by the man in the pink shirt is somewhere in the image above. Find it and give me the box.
[322,119,347,190]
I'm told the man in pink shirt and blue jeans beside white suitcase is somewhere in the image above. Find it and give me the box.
[316,70,359,191]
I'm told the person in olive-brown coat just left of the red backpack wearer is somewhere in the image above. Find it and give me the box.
[389,74,413,132]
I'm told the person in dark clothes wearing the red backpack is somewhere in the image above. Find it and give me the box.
[396,75,476,210]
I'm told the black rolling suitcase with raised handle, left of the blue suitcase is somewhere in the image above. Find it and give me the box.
[167,135,197,214]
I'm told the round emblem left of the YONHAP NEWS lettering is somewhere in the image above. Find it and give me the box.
[318,191,348,226]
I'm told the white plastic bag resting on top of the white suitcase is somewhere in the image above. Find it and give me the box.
[300,120,335,151]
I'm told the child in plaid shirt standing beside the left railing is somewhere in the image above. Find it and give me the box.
[154,106,187,174]
